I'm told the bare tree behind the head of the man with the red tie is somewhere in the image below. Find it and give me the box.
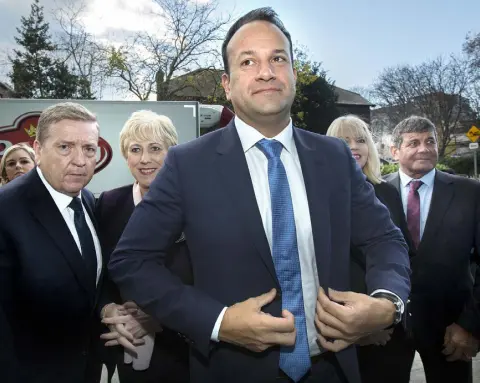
[373,56,474,156]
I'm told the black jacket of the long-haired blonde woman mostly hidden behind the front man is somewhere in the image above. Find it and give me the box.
[350,182,412,296]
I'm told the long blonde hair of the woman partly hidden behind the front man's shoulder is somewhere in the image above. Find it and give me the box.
[327,114,384,185]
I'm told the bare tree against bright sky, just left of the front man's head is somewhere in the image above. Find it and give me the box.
[103,0,230,100]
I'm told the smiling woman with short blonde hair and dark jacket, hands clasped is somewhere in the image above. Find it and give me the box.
[96,110,193,383]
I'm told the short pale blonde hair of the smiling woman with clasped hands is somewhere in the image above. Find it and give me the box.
[120,110,178,158]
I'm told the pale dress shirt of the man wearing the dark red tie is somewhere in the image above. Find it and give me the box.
[398,169,435,239]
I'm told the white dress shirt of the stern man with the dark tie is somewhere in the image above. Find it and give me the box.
[36,166,102,284]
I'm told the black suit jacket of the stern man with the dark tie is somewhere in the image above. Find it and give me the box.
[0,169,104,383]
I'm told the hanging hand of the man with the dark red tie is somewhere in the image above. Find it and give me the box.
[442,323,478,362]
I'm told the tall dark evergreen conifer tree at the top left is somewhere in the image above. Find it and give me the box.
[10,0,91,99]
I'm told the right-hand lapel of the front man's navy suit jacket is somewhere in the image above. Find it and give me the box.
[293,128,331,288]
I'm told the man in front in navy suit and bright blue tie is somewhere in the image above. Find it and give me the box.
[109,8,410,383]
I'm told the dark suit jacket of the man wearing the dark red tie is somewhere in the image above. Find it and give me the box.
[387,170,480,346]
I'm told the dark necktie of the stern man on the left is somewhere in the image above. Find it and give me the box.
[68,197,97,287]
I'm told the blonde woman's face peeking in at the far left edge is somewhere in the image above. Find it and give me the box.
[0,143,35,185]
